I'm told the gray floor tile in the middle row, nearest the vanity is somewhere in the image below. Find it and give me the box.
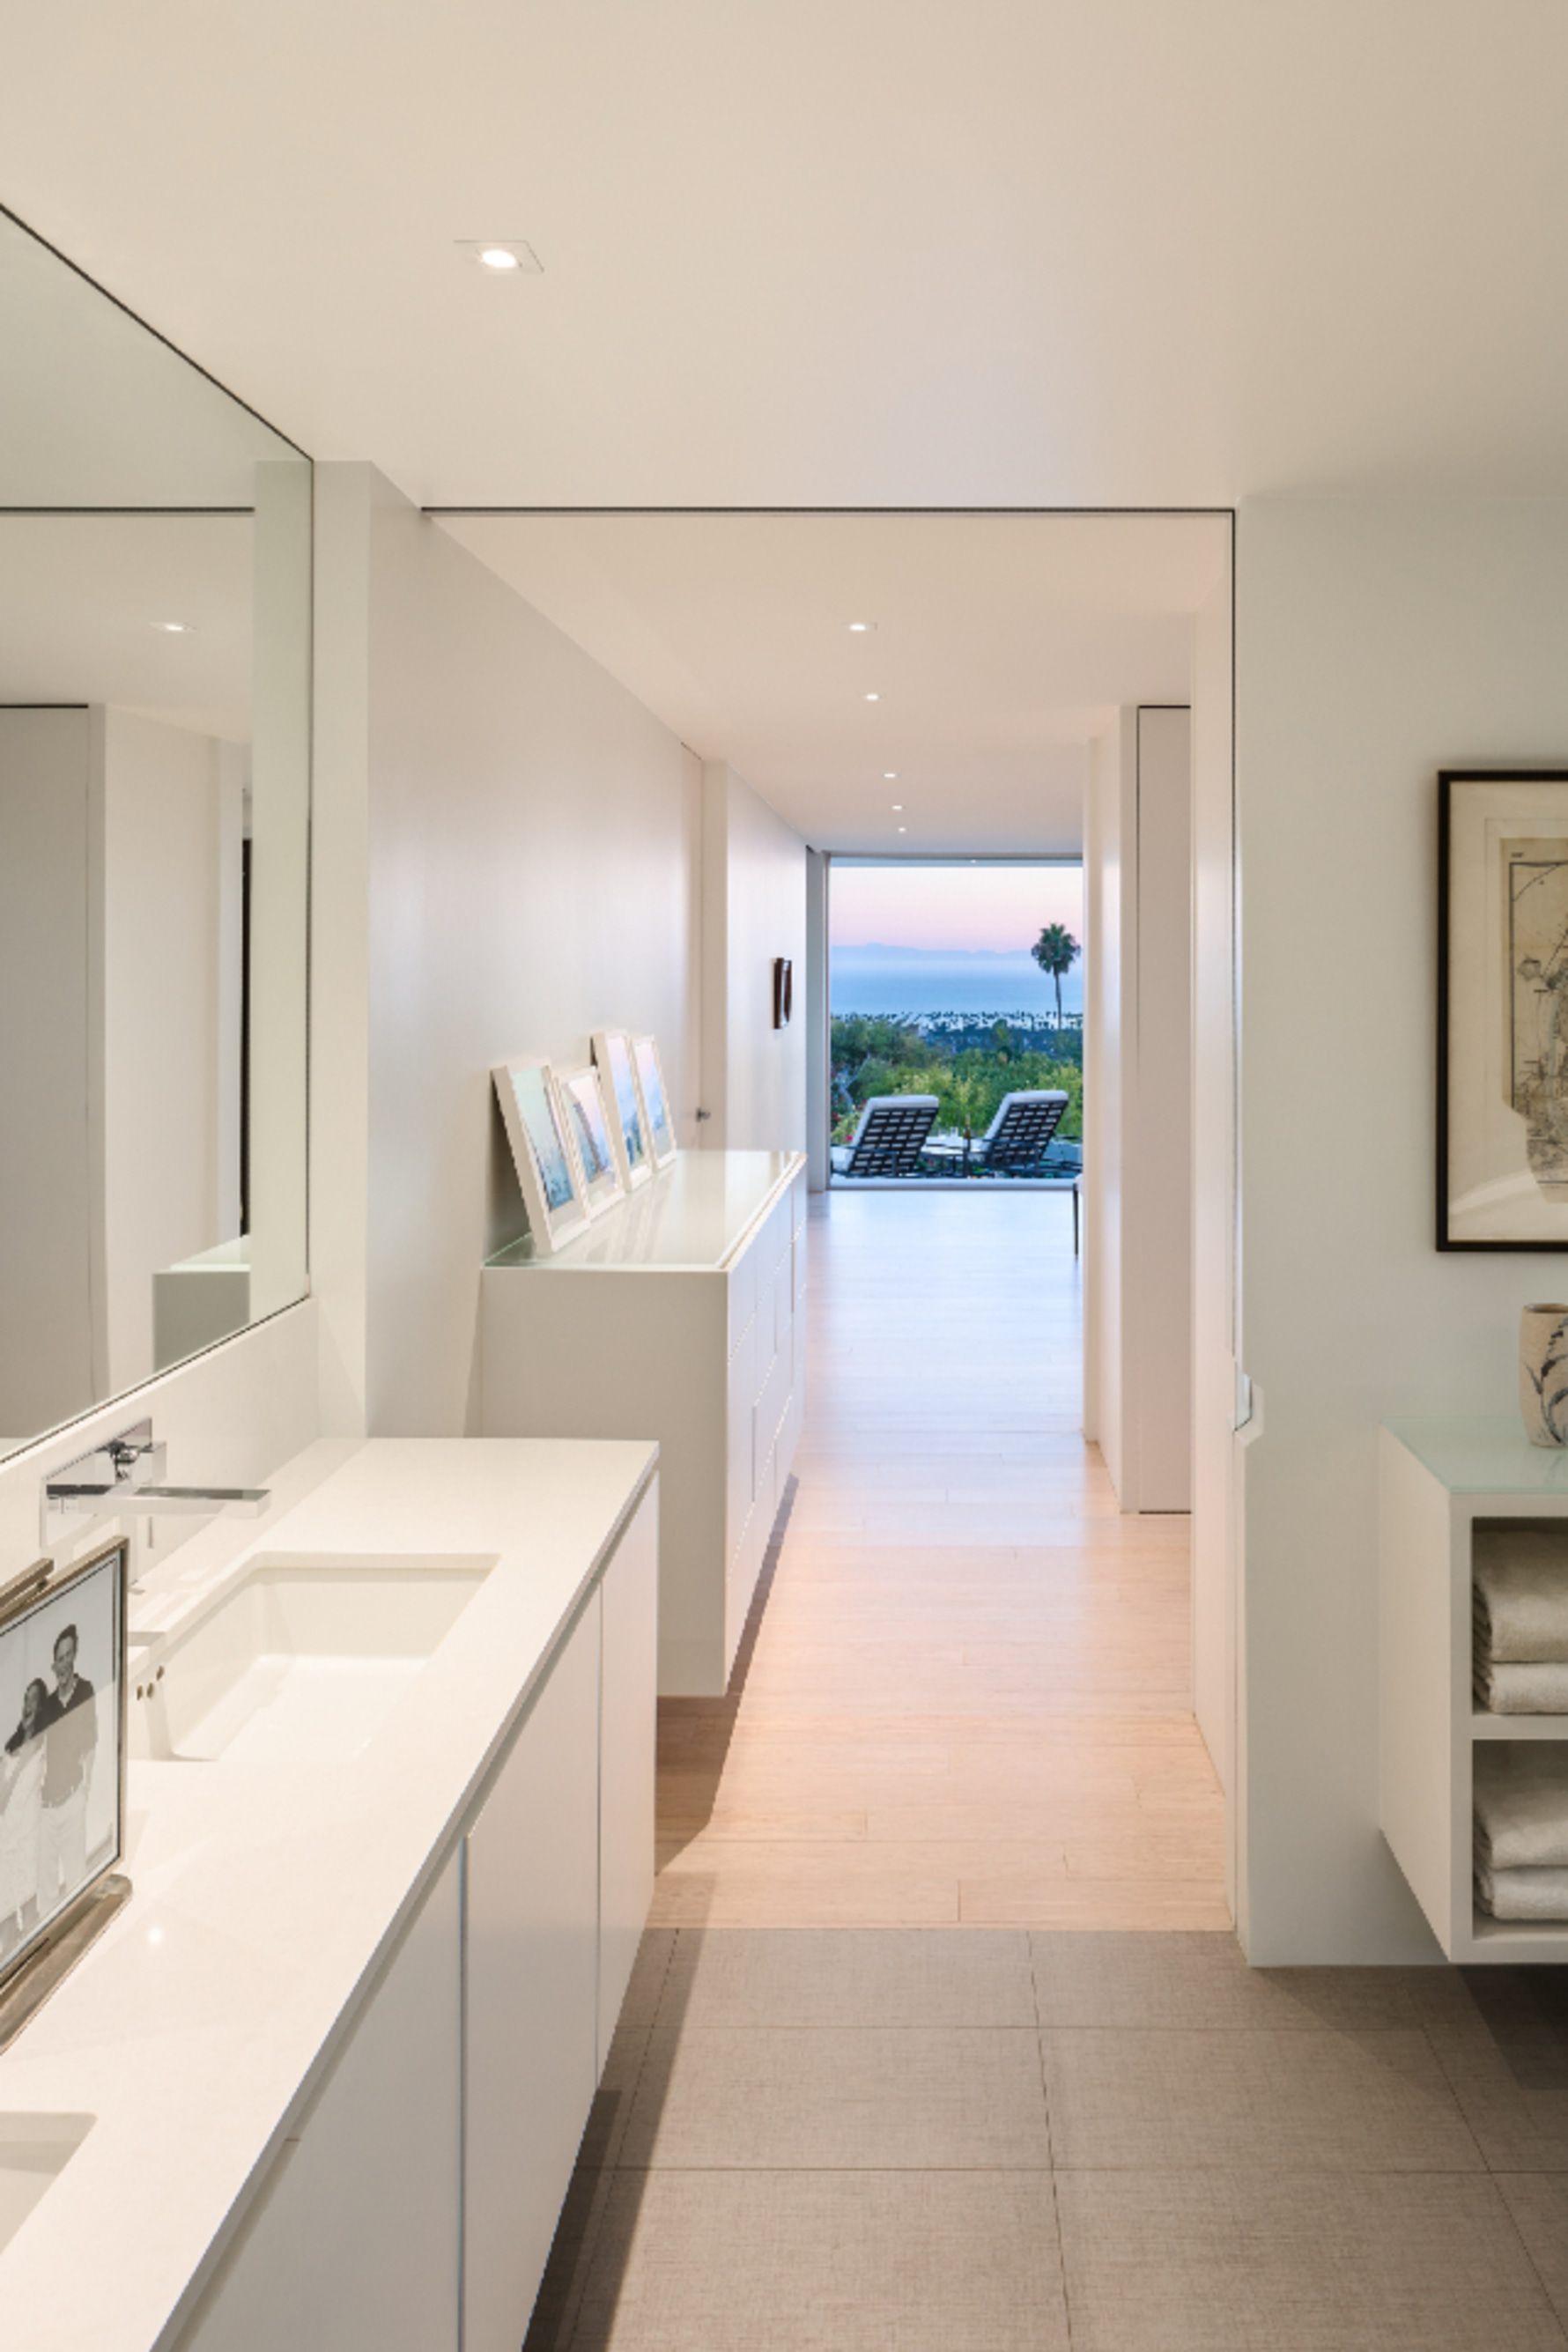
[621,2028,1051,2171]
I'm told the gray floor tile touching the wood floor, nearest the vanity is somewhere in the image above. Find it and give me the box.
[658,1928,1034,2035]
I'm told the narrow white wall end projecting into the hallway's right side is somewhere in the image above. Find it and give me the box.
[1084,708,1192,1510]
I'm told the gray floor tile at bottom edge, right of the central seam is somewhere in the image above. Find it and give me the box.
[1055,2171,1564,2352]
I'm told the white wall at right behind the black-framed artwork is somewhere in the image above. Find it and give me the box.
[1237,499,1568,1962]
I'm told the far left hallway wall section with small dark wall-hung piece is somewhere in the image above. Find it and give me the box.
[703,759,811,1150]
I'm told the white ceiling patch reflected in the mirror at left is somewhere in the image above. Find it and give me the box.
[0,515,254,743]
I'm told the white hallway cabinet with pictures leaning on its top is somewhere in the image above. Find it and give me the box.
[479,1150,806,1698]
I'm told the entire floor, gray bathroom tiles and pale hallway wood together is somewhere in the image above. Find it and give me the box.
[527,1194,1568,2352]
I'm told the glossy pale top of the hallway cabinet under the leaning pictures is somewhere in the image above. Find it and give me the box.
[489,1152,806,1275]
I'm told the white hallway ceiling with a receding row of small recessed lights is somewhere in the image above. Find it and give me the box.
[440,515,1227,854]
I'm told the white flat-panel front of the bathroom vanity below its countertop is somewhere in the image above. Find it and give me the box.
[174,1477,658,2352]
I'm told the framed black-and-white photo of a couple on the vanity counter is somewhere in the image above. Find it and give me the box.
[0,1541,127,1992]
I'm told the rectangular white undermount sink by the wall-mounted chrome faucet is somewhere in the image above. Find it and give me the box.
[131,1559,489,1764]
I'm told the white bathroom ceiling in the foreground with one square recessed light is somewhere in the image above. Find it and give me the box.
[0,0,1568,506]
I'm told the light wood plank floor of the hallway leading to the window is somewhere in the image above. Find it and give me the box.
[651,1187,1230,1928]
